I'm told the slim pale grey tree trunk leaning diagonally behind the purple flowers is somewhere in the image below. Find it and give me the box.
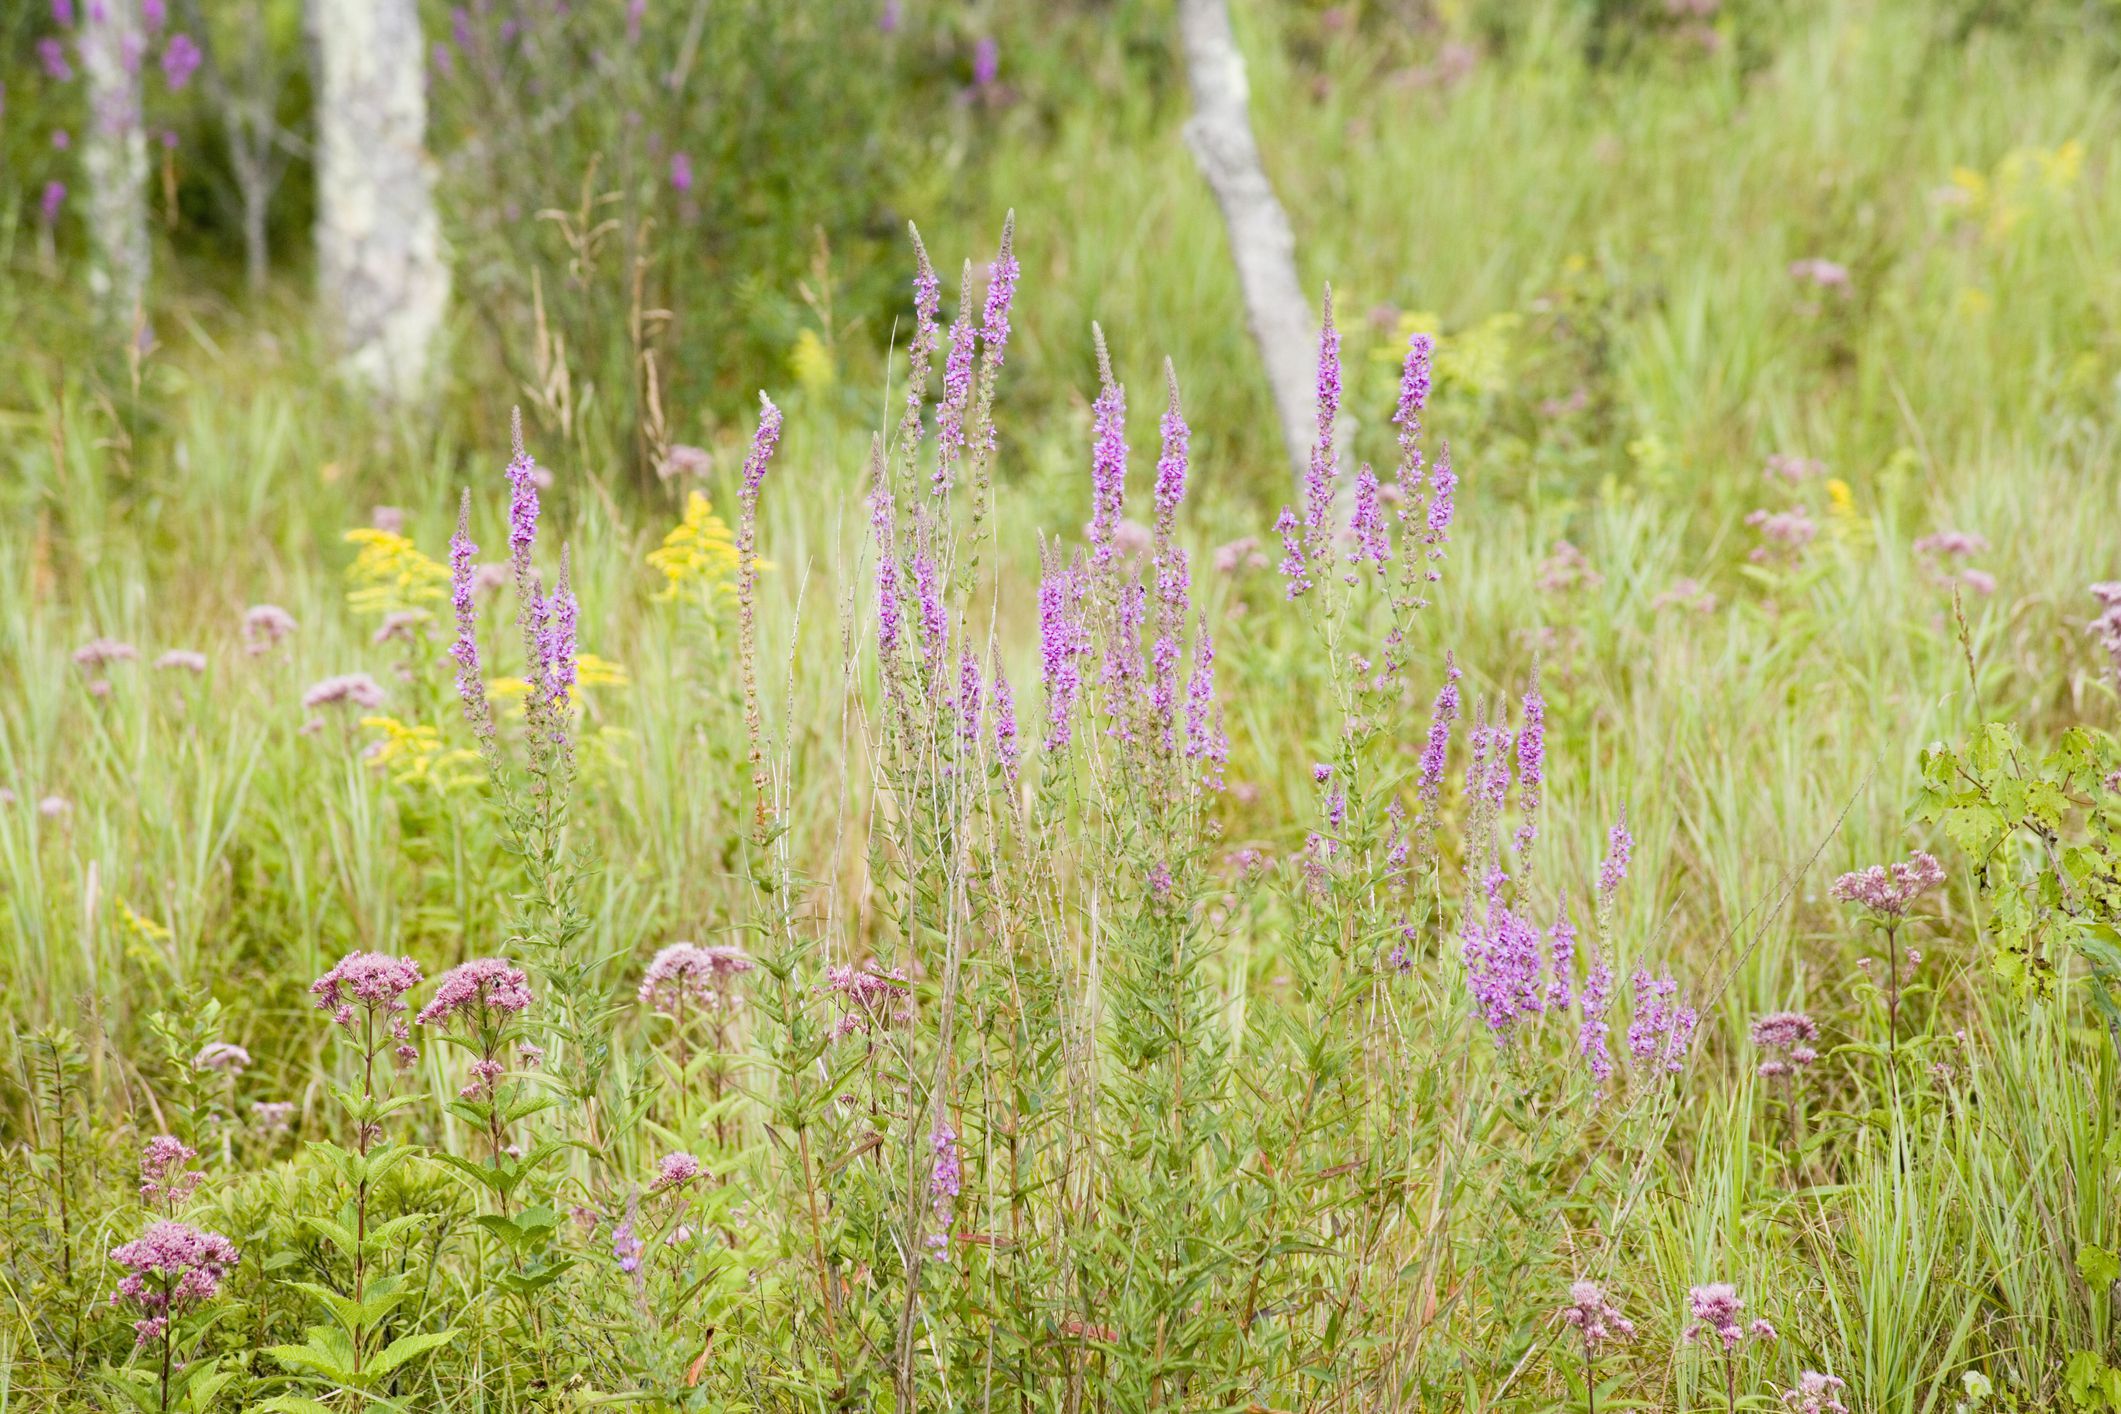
[1179,0,1317,483]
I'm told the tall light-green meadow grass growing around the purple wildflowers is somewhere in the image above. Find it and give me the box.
[0,0,2121,1412]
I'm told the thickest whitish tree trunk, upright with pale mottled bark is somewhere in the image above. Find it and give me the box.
[310,0,450,399]
